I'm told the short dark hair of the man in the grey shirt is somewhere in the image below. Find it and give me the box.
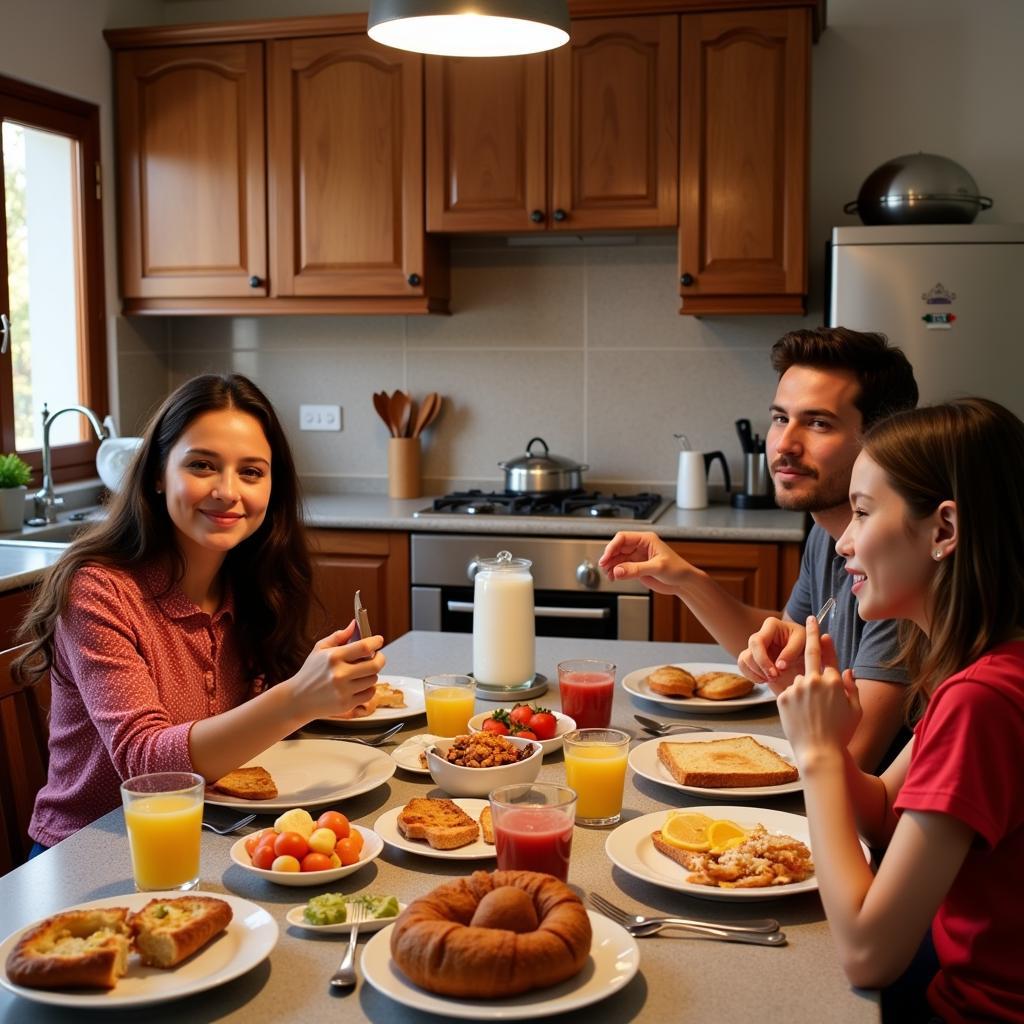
[771,327,918,430]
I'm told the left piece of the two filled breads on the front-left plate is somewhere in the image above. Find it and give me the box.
[6,906,131,988]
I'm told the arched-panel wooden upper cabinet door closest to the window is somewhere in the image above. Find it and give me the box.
[117,43,266,298]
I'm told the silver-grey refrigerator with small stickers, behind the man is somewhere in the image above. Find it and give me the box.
[827,224,1024,419]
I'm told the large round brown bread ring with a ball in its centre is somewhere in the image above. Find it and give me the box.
[391,871,592,999]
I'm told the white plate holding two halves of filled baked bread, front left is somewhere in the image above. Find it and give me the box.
[0,891,278,1007]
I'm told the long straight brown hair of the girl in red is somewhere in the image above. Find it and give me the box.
[864,398,1024,708]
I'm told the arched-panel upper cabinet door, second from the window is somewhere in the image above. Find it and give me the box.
[267,35,425,296]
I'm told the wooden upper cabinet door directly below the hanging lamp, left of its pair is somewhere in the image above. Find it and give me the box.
[426,53,550,231]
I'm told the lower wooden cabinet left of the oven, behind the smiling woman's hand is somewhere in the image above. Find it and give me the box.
[307,529,410,642]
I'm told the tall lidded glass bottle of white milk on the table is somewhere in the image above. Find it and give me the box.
[473,551,534,688]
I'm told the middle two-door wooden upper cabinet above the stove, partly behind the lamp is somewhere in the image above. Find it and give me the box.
[426,14,679,232]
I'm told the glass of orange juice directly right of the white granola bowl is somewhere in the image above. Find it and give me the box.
[563,729,631,825]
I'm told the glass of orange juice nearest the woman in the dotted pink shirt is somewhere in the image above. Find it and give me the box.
[121,771,206,892]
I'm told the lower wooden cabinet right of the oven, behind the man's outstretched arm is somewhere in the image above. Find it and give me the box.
[651,541,801,643]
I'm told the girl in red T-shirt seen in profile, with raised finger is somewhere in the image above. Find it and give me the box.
[778,398,1024,1022]
